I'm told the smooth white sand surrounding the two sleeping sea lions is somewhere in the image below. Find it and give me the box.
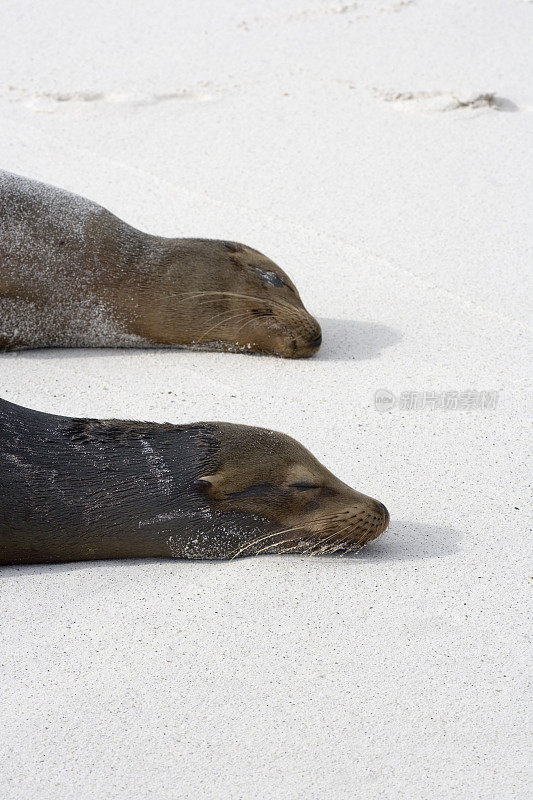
[0,0,533,800]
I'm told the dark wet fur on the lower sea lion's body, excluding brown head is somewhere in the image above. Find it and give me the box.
[0,400,274,564]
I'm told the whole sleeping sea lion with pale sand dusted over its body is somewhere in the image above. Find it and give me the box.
[0,172,322,358]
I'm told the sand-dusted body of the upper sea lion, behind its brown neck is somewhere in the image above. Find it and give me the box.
[0,172,141,350]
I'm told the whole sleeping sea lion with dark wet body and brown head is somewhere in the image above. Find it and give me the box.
[0,400,389,564]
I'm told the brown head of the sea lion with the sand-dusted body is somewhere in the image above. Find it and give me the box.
[162,239,322,358]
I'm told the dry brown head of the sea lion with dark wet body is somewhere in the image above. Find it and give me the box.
[195,423,389,557]
